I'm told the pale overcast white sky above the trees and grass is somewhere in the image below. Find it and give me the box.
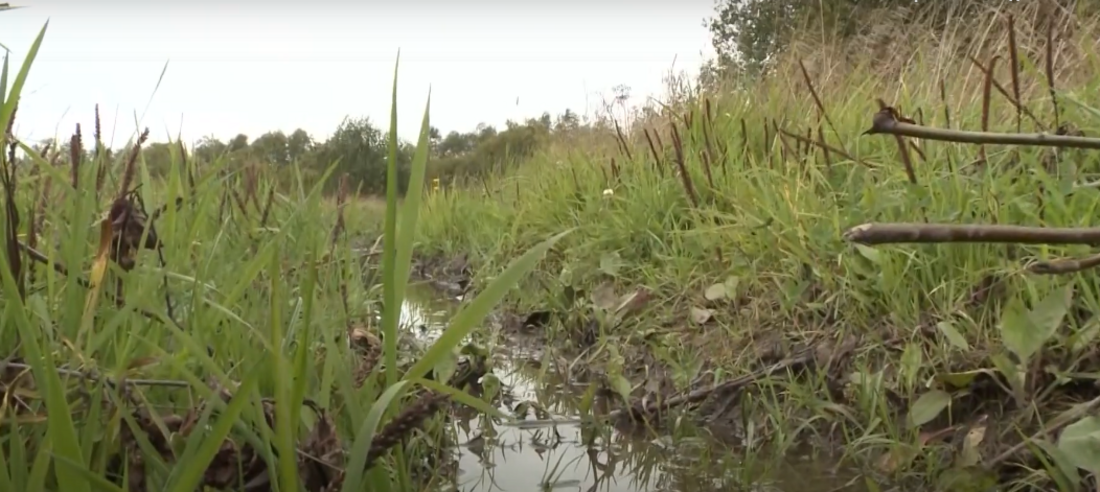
[0,0,714,146]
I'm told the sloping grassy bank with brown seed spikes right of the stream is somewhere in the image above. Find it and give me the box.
[418,2,1100,490]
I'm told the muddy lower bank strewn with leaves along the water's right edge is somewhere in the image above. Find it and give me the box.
[404,252,1100,489]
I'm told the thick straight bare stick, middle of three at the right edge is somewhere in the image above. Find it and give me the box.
[844,222,1100,245]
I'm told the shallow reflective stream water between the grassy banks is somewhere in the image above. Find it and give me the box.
[402,292,866,492]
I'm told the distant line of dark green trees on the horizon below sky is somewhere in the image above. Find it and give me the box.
[32,110,587,195]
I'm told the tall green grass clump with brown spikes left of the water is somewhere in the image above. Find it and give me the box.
[0,20,568,492]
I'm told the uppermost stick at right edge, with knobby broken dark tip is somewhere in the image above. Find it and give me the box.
[864,107,1100,150]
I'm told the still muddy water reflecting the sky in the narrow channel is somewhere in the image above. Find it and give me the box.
[402,289,862,492]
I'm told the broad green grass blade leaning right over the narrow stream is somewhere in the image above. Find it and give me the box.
[402,229,573,381]
